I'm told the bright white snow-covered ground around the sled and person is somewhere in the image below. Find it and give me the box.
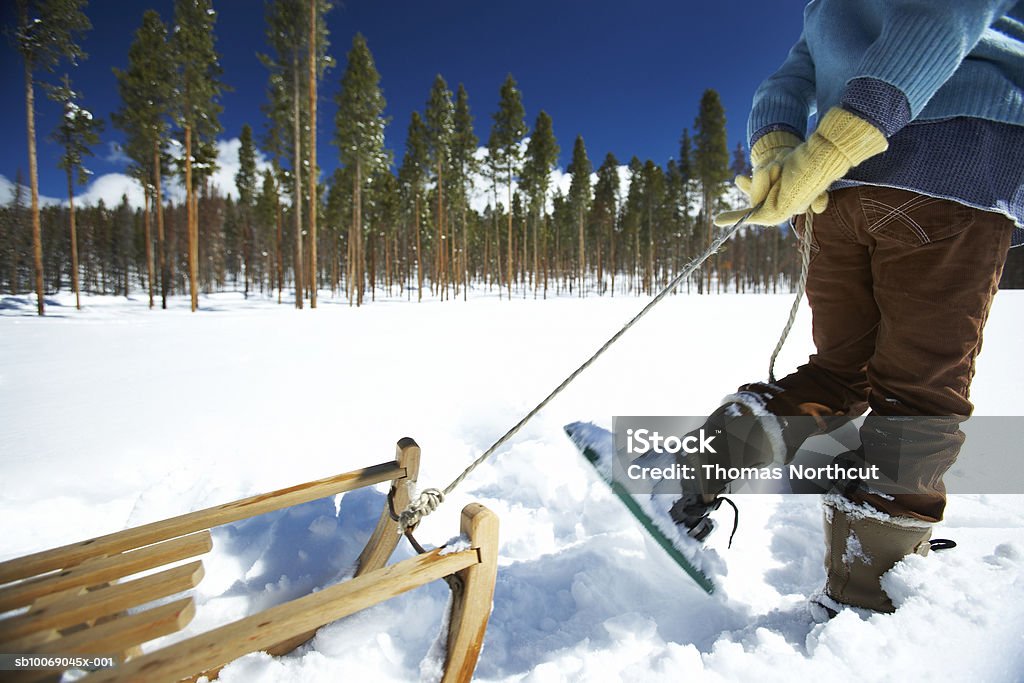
[0,292,1024,683]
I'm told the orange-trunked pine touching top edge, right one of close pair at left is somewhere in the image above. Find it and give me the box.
[171,0,223,311]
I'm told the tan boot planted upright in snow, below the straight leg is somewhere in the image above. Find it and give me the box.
[824,497,932,612]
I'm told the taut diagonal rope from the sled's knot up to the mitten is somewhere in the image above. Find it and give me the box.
[398,205,760,532]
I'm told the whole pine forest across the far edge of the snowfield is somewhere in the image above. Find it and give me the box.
[0,0,815,313]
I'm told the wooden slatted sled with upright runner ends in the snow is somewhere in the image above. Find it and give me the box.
[0,438,498,683]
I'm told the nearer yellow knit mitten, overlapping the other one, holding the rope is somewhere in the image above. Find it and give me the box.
[715,106,889,226]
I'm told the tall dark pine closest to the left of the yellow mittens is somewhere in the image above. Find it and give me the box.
[693,89,729,293]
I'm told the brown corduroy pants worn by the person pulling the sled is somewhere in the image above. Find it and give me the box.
[740,186,1013,521]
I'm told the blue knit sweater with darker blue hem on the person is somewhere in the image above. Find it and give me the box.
[749,0,1024,231]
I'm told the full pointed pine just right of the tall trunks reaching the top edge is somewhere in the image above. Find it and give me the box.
[335,34,390,305]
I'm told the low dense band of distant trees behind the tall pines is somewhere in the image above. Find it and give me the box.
[0,164,815,305]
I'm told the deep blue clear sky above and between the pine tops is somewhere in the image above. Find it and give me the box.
[0,0,805,202]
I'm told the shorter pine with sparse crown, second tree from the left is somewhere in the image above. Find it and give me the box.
[49,74,99,308]
